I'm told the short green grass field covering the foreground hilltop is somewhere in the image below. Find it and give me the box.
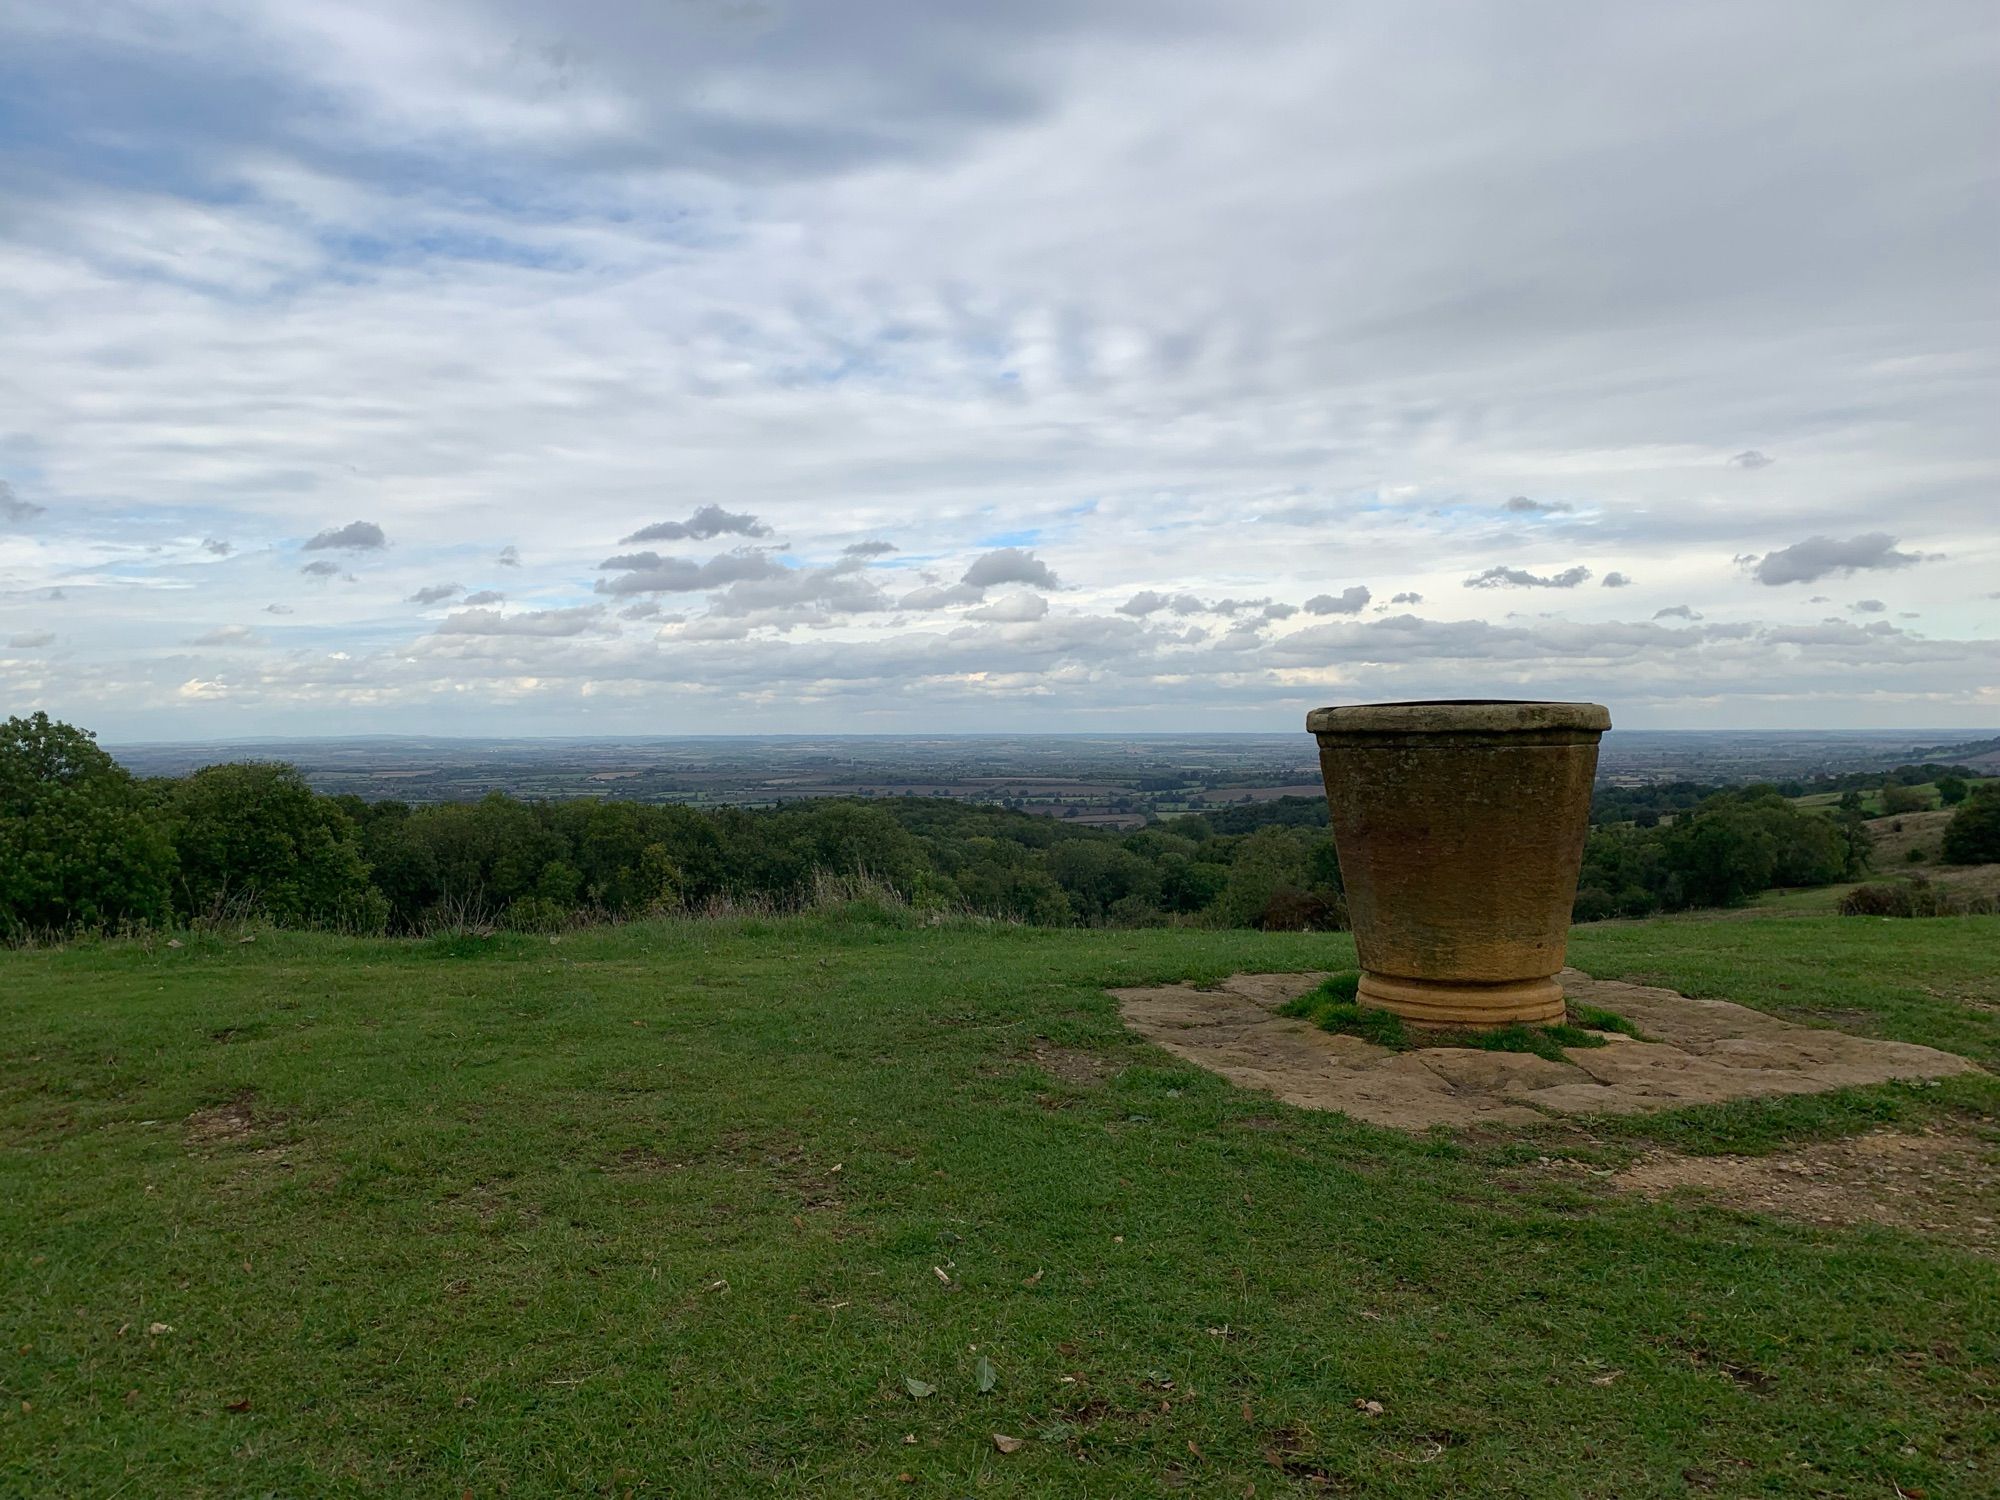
[0,912,2000,1498]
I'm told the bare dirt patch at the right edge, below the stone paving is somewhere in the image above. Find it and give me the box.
[1610,1130,2000,1254]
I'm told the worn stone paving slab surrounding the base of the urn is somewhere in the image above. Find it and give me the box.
[1112,968,1974,1130]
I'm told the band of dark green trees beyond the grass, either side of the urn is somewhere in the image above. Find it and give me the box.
[0,714,1984,940]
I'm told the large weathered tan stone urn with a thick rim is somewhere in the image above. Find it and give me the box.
[1306,698,1612,1026]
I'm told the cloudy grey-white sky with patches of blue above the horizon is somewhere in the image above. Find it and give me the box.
[0,0,2000,740]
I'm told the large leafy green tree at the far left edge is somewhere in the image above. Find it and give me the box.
[0,712,174,934]
